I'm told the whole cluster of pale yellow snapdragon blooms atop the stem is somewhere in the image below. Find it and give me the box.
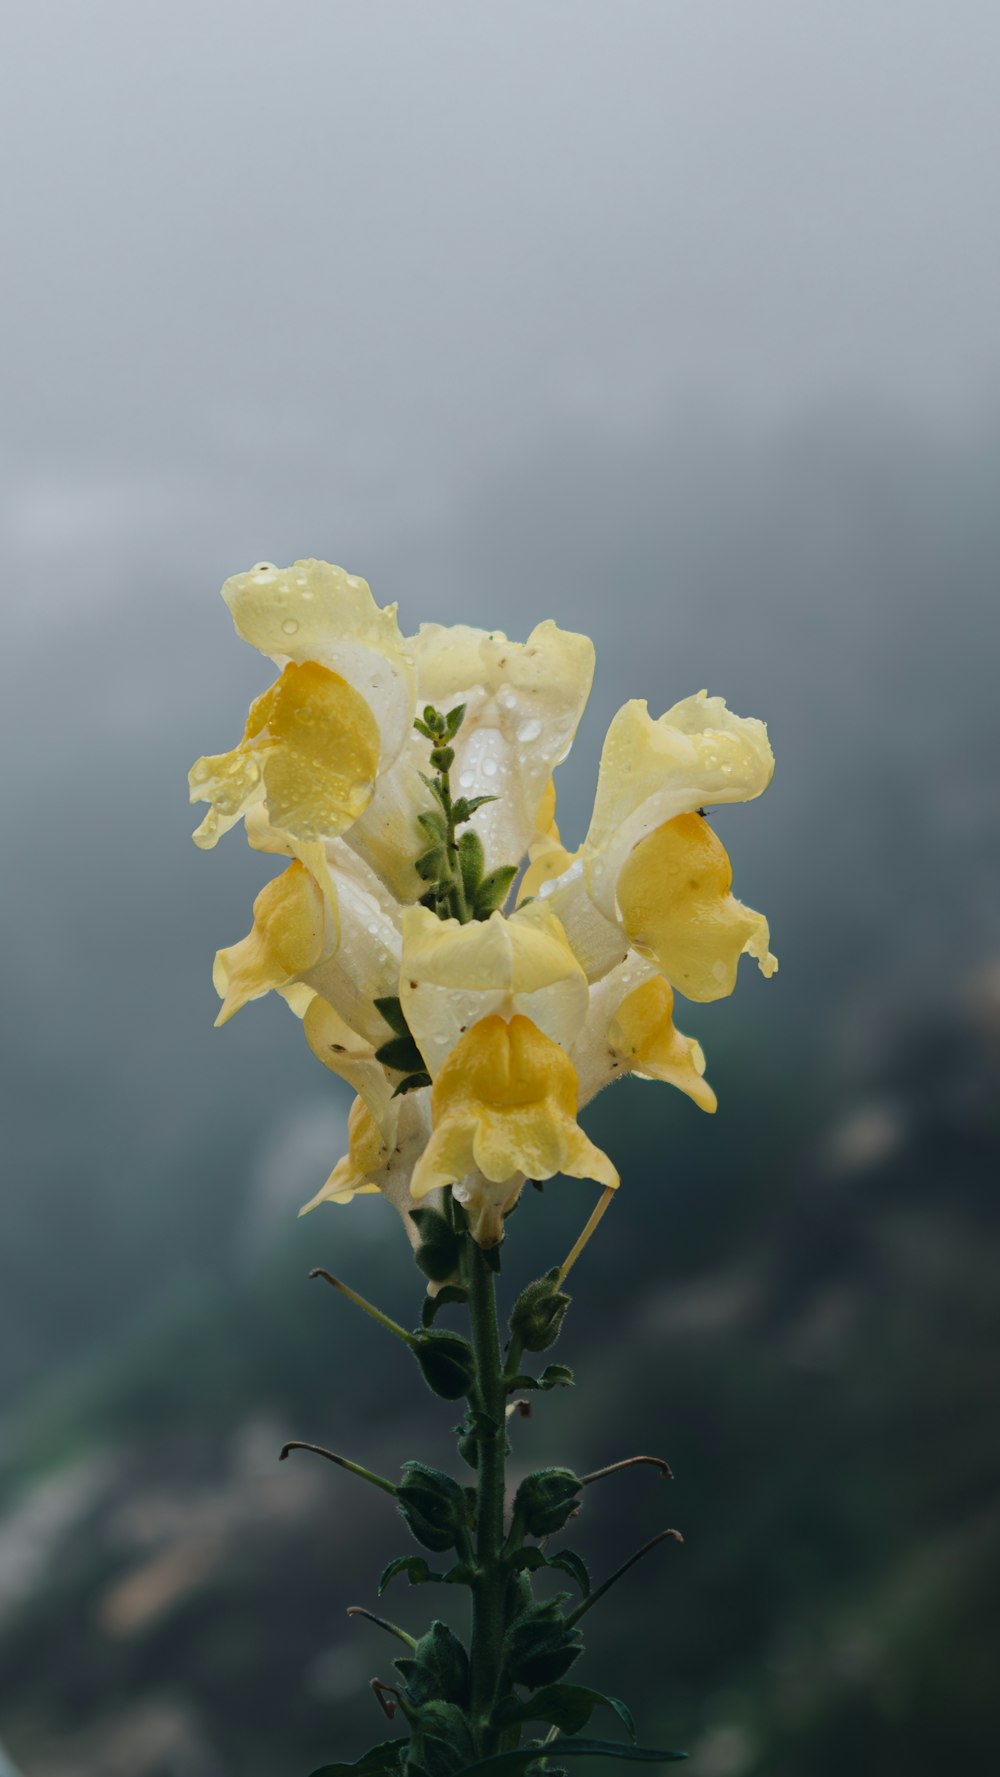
[190,562,778,1247]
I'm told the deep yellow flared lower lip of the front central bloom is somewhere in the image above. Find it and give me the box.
[410,1013,618,1246]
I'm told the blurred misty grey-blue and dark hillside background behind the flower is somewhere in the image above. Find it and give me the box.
[0,0,1000,1777]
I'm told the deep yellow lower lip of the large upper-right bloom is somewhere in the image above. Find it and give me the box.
[618,814,778,1000]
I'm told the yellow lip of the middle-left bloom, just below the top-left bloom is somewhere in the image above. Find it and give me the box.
[213,862,325,1024]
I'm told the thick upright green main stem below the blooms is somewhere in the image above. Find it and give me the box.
[465,1240,506,1754]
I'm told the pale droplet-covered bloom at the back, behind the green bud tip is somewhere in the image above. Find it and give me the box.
[350,618,593,901]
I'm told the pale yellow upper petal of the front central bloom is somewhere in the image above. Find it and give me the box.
[400,903,588,1077]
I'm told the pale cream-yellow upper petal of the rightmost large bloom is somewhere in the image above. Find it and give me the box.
[584,691,774,919]
